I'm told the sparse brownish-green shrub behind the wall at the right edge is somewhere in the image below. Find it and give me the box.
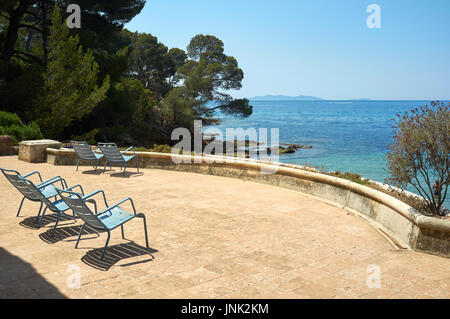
[387,102,450,215]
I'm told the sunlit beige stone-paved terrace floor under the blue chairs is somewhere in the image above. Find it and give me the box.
[0,156,450,298]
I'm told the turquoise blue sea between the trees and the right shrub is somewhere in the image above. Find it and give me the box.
[215,101,449,207]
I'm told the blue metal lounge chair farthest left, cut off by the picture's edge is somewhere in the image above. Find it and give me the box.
[0,167,67,217]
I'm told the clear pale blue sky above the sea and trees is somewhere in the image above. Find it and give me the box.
[126,0,450,100]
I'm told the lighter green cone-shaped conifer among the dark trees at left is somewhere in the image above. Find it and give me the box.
[35,7,110,138]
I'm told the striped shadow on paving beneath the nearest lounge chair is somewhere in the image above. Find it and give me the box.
[81,241,158,271]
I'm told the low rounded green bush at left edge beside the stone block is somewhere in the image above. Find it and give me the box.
[0,111,43,145]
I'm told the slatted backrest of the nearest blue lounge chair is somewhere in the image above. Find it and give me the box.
[56,188,106,229]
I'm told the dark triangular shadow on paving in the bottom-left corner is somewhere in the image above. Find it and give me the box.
[0,247,66,299]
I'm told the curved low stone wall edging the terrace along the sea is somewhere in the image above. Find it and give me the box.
[47,149,450,257]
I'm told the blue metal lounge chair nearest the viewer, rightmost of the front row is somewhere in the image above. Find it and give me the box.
[56,188,149,260]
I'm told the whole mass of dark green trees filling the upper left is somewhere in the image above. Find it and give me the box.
[0,0,252,146]
